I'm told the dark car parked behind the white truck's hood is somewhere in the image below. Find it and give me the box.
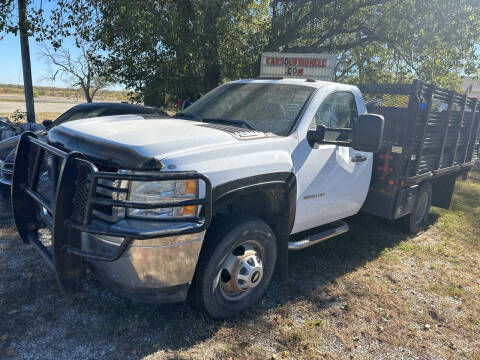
[0,102,168,192]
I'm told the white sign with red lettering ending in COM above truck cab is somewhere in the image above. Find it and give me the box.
[260,53,336,81]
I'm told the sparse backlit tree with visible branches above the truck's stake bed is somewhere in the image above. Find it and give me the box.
[268,0,480,87]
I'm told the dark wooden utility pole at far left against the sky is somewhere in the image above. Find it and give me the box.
[18,0,35,123]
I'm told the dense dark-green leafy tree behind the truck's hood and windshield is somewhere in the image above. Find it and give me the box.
[47,0,270,105]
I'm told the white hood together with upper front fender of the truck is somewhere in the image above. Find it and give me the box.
[48,115,298,185]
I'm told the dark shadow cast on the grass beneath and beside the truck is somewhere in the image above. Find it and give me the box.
[0,190,436,359]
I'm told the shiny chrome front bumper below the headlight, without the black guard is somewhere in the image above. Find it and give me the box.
[82,231,205,303]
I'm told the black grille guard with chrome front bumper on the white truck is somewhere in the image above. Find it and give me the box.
[12,133,212,302]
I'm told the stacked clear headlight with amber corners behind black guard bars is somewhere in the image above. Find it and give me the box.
[127,179,198,219]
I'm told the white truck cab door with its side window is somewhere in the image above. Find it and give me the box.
[292,91,373,233]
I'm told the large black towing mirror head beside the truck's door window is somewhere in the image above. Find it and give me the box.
[351,114,385,152]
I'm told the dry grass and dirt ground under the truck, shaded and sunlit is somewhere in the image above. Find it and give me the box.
[0,172,480,359]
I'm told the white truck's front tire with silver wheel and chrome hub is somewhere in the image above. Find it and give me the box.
[191,215,277,319]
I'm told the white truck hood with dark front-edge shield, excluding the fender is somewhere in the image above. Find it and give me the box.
[48,115,242,170]
